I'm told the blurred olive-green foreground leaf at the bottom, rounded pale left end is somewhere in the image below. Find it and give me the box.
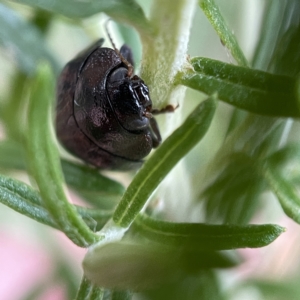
[83,241,233,291]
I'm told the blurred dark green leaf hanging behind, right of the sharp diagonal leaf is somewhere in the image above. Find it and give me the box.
[199,114,286,225]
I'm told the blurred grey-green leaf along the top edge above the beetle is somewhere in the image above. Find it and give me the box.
[14,0,152,34]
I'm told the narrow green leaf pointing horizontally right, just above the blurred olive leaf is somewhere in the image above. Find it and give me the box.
[135,215,285,251]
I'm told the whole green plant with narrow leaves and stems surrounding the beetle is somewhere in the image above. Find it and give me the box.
[0,0,300,300]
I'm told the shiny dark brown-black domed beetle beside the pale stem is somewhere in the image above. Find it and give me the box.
[56,39,161,170]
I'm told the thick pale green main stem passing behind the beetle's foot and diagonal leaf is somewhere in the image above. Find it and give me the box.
[141,0,197,220]
